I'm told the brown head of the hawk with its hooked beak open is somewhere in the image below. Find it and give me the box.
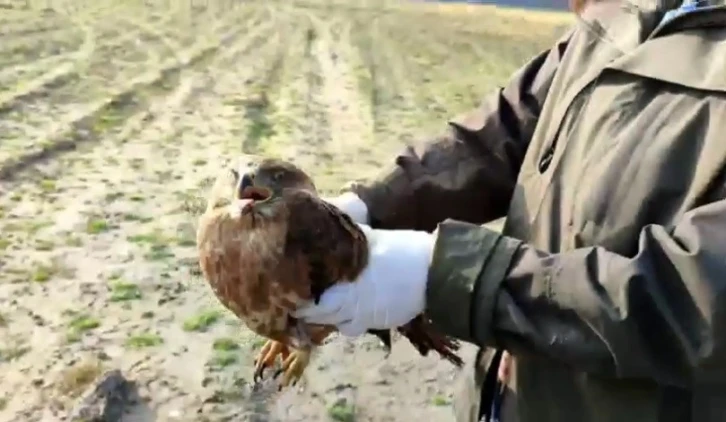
[232,158,316,217]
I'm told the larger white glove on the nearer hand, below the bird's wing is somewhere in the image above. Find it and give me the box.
[293,224,435,337]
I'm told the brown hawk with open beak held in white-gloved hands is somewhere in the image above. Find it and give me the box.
[197,159,462,389]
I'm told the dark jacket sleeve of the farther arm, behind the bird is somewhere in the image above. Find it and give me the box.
[350,34,569,231]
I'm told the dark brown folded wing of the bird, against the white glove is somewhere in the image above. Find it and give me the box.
[283,189,368,302]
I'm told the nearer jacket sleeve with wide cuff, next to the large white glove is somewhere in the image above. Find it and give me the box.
[427,199,726,386]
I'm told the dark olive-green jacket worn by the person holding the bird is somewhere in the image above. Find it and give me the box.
[352,0,726,422]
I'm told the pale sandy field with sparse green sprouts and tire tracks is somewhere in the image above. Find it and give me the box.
[0,0,570,422]
